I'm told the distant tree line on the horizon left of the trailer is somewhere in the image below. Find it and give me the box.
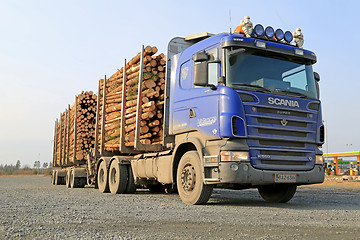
[0,160,52,175]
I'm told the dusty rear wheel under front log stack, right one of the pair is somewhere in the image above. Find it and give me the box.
[109,160,128,194]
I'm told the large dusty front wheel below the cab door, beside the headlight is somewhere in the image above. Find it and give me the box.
[176,151,213,205]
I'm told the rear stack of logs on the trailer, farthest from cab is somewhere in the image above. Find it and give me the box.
[56,91,97,166]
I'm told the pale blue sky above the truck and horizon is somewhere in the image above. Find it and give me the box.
[0,0,360,166]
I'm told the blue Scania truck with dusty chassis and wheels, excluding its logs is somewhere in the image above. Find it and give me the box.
[52,18,325,204]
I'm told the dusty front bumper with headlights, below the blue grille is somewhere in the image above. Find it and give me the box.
[205,162,325,185]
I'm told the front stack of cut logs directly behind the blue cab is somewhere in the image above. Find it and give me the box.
[99,46,166,152]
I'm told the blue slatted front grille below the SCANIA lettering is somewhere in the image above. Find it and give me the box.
[244,95,321,171]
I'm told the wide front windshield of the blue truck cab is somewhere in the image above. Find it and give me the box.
[226,49,318,99]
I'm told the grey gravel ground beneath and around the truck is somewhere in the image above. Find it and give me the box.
[0,176,360,239]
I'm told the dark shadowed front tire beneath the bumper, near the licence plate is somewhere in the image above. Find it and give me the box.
[258,184,297,203]
